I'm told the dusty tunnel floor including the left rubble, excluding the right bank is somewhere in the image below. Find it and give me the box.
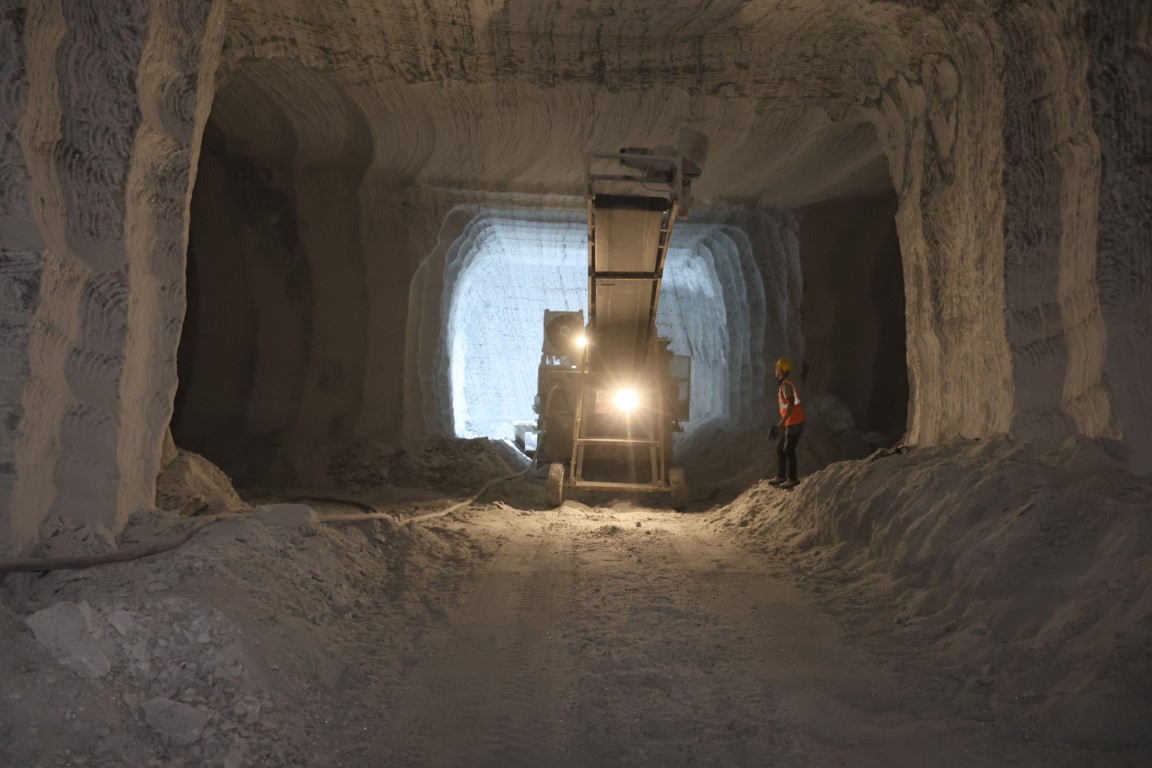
[0,479,1138,768]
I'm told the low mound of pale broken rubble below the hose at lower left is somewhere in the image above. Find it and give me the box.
[0,492,482,768]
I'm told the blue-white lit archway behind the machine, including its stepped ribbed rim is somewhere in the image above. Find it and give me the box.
[428,211,801,460]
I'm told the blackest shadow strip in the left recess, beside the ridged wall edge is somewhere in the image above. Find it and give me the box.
[172,131,312,480]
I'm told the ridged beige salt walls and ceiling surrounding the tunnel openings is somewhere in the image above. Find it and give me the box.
[0,0,1152,553]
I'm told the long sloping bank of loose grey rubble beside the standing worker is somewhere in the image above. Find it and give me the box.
[713,438,1152,748]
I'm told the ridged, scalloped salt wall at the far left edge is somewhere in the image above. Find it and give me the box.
[0,0,222,553]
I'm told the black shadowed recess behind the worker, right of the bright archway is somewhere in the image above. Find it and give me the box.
[798,192,908,442]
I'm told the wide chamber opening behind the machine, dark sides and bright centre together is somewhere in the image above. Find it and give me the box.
[173,55,907,492]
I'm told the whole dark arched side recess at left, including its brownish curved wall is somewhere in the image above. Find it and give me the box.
[172,63,387,484]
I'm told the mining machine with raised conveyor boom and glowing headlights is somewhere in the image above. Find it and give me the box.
[533,129,707,510]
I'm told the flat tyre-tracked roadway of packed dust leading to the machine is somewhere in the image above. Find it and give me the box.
[380,508,1075,768]
